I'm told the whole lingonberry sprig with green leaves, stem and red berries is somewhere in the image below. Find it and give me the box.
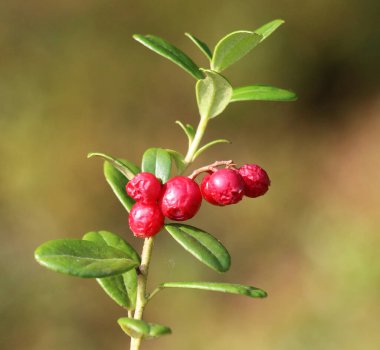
[35,20,296,350]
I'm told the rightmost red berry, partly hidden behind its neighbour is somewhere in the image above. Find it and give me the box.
[239,164,270,198]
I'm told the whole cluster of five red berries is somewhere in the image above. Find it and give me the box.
[126,164,270,238]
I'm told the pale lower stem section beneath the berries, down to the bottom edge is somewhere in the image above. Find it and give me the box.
[131,237,154,350]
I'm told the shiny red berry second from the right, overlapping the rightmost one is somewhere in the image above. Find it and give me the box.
[201,169,244,206]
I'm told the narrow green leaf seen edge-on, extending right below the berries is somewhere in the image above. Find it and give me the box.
[159,282,268,298]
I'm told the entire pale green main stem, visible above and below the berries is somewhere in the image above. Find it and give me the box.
[130,113,209,350]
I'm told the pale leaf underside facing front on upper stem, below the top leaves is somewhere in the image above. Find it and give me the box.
[196,70,232,119]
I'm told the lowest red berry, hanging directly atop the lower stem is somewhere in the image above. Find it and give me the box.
[129,203,165,238]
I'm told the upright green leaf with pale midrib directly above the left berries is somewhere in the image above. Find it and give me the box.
[141,148,172,183]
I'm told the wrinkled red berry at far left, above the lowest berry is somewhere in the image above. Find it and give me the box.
[125,172,162,203]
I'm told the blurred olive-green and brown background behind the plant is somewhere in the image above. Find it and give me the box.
[0,0,380,350]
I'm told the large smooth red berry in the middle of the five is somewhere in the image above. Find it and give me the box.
[160,176,202,221]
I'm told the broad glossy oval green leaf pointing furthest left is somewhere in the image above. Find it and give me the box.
[34,239,138,278]
